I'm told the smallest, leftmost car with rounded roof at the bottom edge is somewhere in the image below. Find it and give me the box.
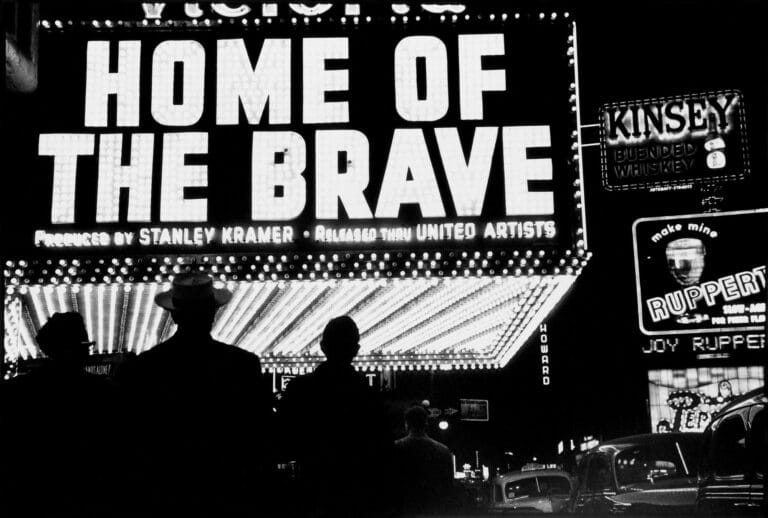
[490,469,573,513]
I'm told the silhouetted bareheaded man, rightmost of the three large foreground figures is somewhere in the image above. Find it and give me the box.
[280,316,392,517]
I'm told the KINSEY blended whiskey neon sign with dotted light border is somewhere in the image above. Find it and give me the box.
[600,90,749,191]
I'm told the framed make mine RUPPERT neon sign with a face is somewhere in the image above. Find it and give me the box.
[633,209,768,335]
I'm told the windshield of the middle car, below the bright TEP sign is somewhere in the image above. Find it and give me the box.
[616,442,687,486]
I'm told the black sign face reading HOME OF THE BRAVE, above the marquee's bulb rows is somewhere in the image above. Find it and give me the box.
[4,13,581,264]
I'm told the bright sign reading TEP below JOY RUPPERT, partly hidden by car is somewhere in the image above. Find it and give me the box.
[648,366,765,433]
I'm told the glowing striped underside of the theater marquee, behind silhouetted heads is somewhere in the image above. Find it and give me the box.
[5,275,575,371]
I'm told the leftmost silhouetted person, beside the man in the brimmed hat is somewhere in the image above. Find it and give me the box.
[0,313,119,516]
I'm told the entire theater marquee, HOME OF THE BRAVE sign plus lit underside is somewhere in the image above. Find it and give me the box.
[3,8,588,374]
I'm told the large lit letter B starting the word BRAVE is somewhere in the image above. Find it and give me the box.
[251,131,307,221]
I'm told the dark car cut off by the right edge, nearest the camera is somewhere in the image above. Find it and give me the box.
[696,387,768,516]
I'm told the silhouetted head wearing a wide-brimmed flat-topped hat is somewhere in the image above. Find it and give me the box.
[155,273,232,334]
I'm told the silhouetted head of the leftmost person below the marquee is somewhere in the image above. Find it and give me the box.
[36,312,93,365]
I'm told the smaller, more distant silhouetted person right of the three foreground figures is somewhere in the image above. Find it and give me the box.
[395,406,453,513]
